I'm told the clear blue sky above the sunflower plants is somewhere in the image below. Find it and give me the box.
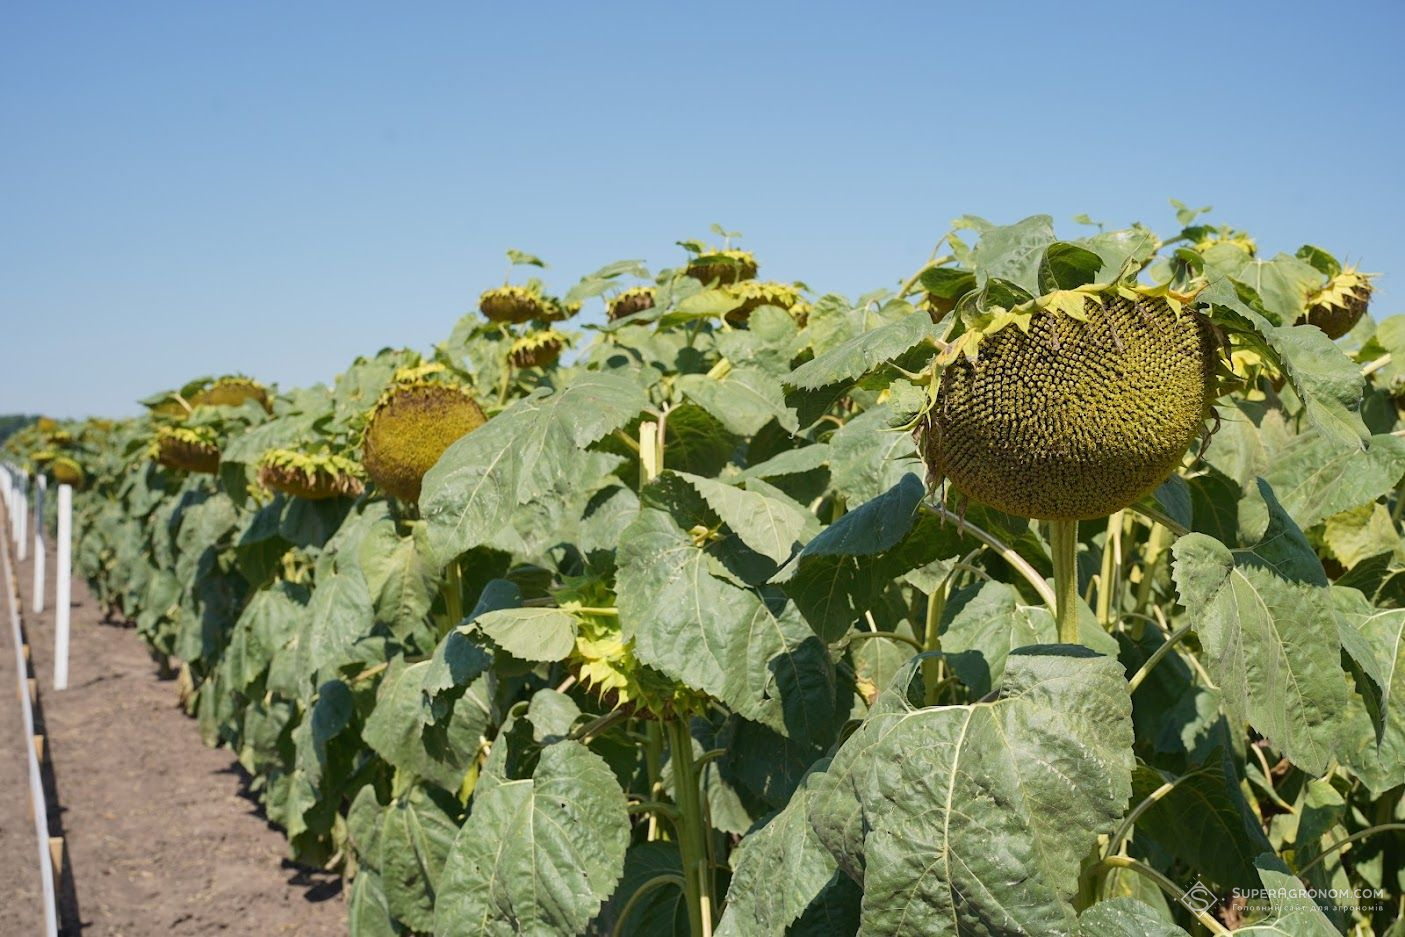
[0,0,1405,416]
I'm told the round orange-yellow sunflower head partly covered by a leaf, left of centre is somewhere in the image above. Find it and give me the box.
[361,372,486,502]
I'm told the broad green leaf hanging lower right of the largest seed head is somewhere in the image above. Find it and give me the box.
[1173,483,1347,774]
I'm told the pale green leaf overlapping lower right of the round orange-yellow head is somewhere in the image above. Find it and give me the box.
[420,372,649,562]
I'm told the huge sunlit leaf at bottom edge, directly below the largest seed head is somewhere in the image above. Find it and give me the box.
[809,646,1132,937]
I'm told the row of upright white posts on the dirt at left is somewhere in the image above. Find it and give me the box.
[0,465,73,690]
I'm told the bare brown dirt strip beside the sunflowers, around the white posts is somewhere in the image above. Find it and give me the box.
[0,508,346,937]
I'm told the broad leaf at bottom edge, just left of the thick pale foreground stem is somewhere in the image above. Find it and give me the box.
[434,742,629,937]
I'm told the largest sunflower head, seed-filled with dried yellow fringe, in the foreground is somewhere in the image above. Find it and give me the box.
[919,288,1220,520]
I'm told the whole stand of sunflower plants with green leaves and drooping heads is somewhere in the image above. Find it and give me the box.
[3,204,1405,937]
